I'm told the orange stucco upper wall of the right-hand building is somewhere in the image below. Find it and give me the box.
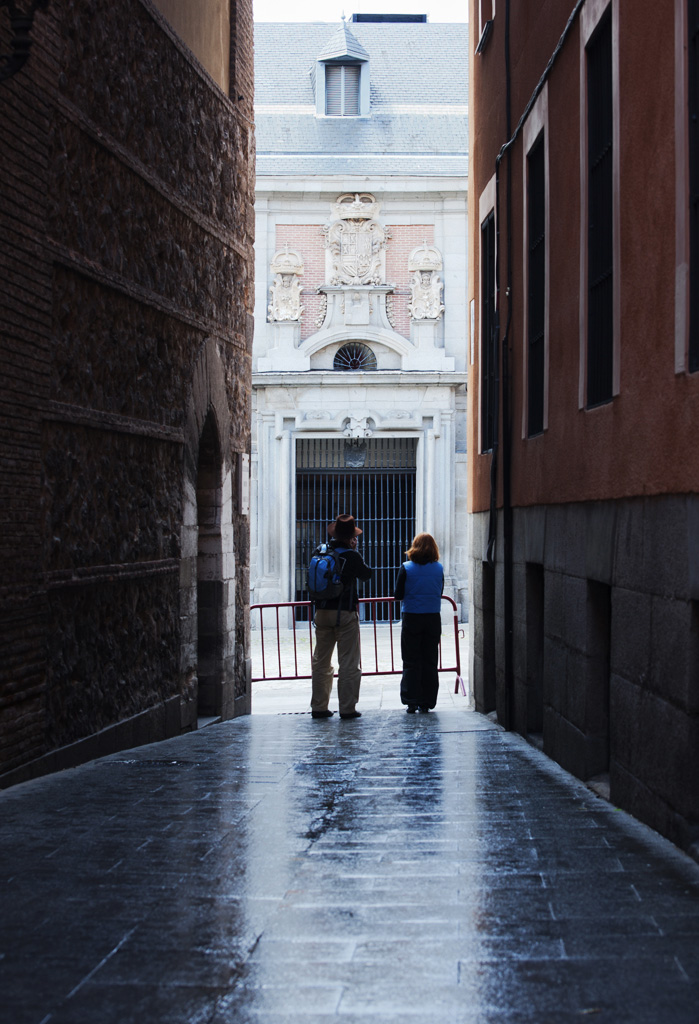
[469,0,699,511]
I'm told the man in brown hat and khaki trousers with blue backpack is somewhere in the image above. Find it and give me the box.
[309,513,373,718]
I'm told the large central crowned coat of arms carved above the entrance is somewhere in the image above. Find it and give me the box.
[323,193,390,286]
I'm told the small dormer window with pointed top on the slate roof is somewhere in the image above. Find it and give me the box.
[311,22,369,118]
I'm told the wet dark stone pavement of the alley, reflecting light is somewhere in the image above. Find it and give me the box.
[0,706,699,1024]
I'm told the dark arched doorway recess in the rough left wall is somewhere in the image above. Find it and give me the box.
[196,410,224,719]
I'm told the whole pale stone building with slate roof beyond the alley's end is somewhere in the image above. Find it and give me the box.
[251,19,470,617]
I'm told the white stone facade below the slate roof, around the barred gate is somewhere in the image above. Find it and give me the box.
[251,176,468,612]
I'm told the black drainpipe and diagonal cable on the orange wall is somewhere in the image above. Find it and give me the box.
[487,0,584,729]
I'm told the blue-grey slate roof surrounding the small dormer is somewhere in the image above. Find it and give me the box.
[255,22,469,176]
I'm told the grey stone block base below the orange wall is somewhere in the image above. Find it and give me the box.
[471,495,699,855]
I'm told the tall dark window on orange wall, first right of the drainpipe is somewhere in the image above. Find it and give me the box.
[527,132,547,437]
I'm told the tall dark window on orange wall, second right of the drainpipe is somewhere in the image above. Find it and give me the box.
[586,11,614,409]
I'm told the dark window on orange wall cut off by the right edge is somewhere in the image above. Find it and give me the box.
[687,0,699,373]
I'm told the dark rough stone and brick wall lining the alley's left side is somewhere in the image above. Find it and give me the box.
[0,0,254,777]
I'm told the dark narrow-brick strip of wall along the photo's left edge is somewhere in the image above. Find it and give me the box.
[0,7,57,765]
